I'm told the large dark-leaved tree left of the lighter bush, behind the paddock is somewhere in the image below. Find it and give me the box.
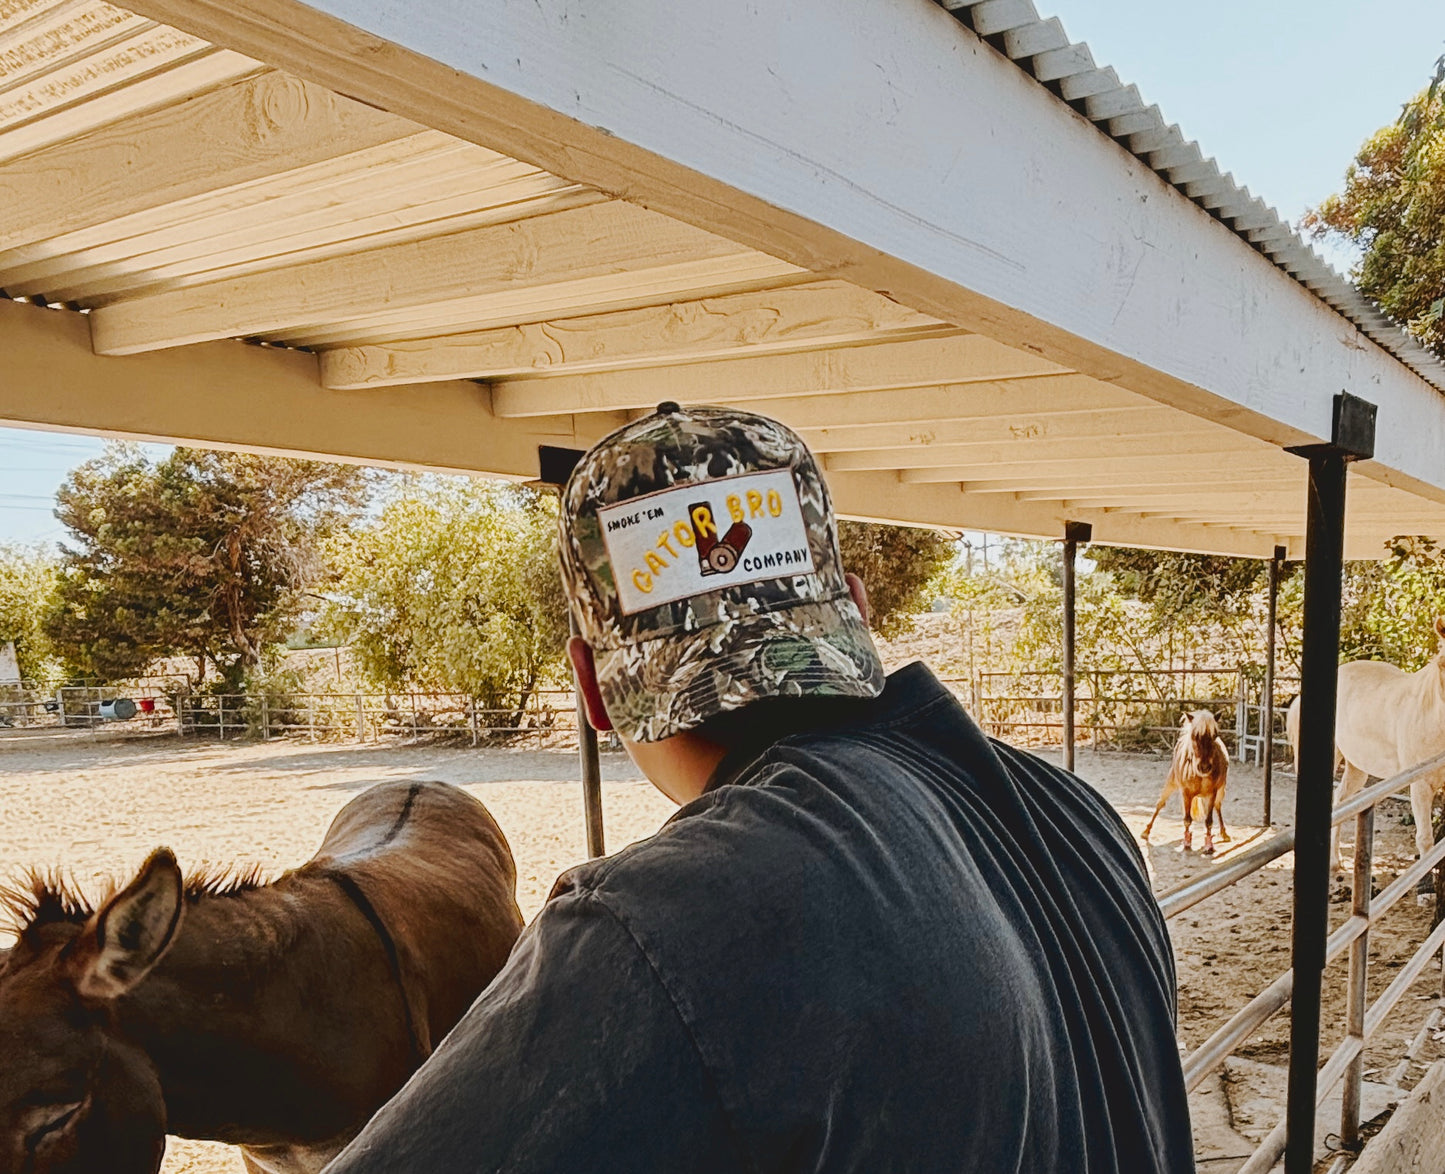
[46,445,368,688]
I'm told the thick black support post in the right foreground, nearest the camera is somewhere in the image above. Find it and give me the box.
[1285,393,1376,1174]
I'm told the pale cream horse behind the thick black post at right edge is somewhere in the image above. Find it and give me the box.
[1285,619,1445,905]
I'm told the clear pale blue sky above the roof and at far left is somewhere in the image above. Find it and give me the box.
[0,0,1445,544]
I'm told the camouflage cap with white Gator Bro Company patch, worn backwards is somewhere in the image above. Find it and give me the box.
[561,403,883,742]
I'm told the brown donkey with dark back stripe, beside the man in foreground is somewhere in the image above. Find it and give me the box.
[0,782,522,1174]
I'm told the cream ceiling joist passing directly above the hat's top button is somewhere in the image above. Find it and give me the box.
[491,334,1062,416]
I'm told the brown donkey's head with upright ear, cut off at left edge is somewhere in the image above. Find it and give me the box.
[0,849,184,1174]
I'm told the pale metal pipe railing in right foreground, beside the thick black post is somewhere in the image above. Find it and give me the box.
[1159,755,1445,1174]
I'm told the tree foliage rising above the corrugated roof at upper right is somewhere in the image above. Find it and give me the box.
[1305,73,1445,347]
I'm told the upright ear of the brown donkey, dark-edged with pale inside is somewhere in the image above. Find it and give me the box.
[68,847,184,999]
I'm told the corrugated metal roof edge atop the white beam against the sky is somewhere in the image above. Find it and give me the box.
[939,0,1445,392]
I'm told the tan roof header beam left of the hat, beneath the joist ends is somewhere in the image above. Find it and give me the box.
[0,299,623,479]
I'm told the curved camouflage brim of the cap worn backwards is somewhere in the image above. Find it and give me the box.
[594,593,883,742]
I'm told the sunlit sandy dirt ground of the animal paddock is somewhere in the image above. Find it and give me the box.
[0,730,1441,1174]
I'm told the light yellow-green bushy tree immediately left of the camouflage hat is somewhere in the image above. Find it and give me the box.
[322,477,566,711]
